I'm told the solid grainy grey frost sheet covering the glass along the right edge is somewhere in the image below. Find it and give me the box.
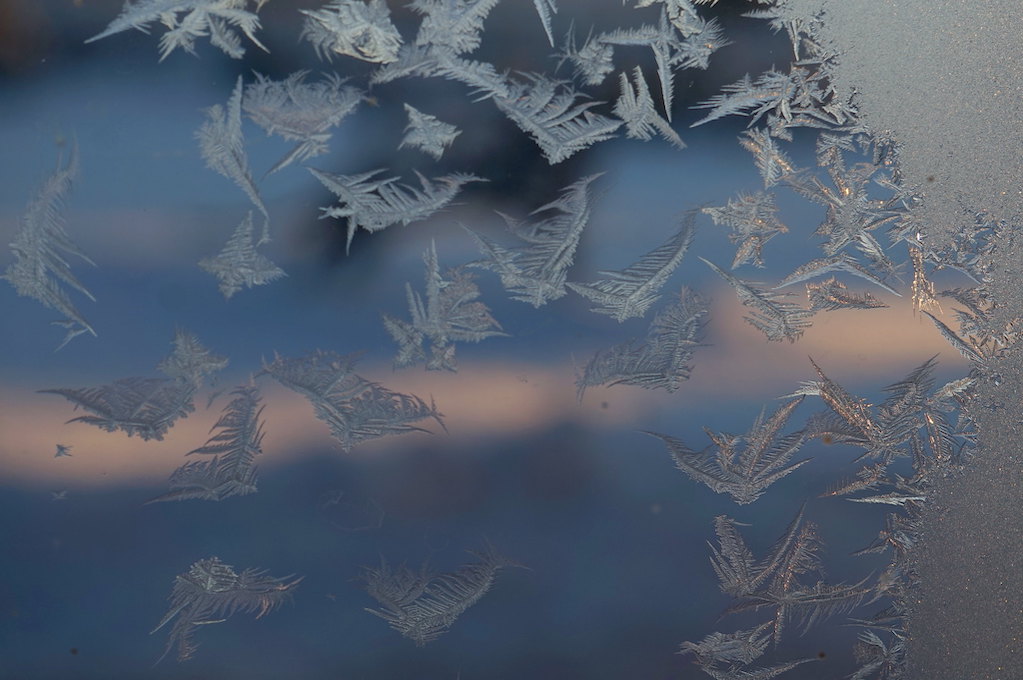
[790,0,1023,680]
